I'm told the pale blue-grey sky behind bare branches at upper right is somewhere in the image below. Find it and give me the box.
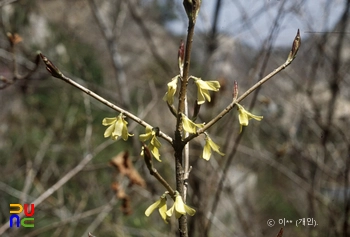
[169,0,345,47]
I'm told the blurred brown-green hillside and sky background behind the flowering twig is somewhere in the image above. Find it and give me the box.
[0,0,350,237]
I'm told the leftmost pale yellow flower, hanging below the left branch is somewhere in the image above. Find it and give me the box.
[102,113,134,141]
